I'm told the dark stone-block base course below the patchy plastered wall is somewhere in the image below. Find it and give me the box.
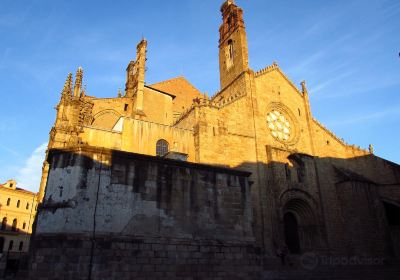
[25,234,262,280]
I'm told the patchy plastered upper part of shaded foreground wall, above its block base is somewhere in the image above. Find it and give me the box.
[37,148,254,242]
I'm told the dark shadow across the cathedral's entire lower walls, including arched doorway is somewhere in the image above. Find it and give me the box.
[10,147,400,279]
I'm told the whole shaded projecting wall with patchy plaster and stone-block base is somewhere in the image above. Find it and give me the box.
[25,147,261,279]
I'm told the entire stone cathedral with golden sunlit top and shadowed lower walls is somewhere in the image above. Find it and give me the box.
[25,0,400,279]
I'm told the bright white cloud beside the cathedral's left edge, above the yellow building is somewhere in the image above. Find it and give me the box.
[16,142,47,192]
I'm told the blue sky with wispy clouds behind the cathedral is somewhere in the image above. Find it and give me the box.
[0,0,400,191]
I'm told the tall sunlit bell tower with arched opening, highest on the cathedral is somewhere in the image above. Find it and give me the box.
[219,0,249,89]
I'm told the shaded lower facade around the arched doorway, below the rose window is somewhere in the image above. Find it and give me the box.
[233,152,400,258]
